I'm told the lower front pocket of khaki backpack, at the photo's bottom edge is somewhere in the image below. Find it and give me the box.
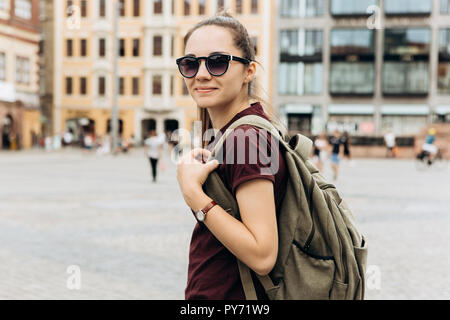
[277,240,335,300]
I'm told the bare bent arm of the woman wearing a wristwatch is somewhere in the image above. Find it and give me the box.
[189,179,278,275]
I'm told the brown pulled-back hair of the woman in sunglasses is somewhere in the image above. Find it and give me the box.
[184,10,281,148]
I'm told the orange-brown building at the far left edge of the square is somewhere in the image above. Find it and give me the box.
[0,0,41,150]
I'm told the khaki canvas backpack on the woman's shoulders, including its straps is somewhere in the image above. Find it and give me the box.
[203,115,367,300]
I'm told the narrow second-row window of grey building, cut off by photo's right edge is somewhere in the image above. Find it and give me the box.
[438,28,450,94]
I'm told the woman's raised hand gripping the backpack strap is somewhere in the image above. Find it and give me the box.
[177,148,219,207]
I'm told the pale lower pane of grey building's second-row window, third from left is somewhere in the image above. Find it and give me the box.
[383,61,429,95]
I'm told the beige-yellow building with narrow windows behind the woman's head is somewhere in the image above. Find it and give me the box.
[44,0,273,142]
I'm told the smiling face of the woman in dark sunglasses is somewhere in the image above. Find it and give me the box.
[184,26,254,108]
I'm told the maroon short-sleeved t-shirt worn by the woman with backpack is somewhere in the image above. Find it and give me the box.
[185,103,287,300]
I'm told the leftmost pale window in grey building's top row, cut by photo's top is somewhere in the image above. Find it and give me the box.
[280,0,325,18]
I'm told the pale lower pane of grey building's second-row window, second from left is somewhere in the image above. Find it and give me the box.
[330,62,375,95]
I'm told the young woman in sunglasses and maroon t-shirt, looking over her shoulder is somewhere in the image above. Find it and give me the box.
[177,13,286,300]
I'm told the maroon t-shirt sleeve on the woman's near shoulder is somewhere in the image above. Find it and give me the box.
[223,126,280,196]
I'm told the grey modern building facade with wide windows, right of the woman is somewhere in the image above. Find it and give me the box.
[272,0,450,141]
